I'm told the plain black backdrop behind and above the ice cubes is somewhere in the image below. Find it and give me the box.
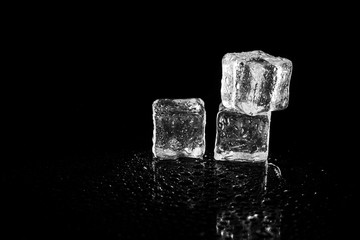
[3,5,356,238]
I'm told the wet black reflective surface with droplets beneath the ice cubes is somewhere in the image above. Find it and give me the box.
[3,151,354,239]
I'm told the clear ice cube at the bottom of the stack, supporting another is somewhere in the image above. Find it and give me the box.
[214,104,271,161]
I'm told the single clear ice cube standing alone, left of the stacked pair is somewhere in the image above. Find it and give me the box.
[152,98,206,159]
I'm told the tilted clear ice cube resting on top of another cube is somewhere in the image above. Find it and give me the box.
[221,51,292,115]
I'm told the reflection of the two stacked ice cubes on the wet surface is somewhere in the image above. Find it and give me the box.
[216,162,281,239]
